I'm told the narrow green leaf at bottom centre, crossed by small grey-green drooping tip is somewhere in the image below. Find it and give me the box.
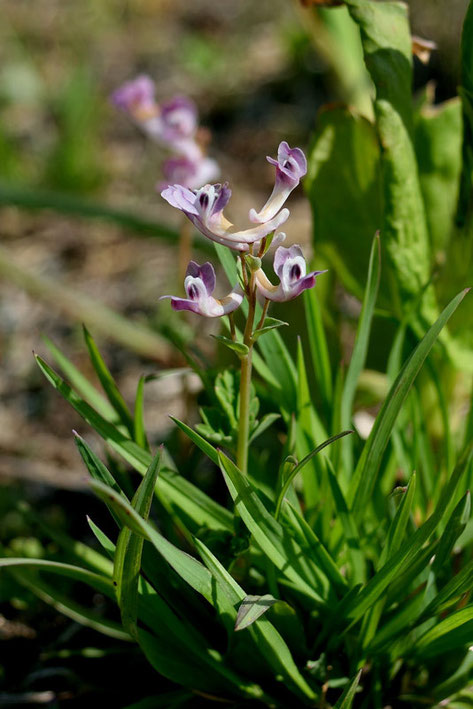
[195,539,316,699]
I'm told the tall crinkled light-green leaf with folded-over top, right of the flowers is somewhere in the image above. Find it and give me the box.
[346,0,435,319]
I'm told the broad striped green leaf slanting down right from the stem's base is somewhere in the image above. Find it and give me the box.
[219,452,324,605]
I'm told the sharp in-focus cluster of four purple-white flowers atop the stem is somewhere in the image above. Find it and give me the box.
[161,141,324,317]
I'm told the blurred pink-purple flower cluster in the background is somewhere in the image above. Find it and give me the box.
[112,75,220,190]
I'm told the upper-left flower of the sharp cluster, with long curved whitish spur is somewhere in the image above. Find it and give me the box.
[161,183,289,251]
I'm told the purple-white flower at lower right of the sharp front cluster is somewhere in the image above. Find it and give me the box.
[256,245,325,302]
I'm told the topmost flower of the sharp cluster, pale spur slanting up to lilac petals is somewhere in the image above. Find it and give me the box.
[250,141,307,222]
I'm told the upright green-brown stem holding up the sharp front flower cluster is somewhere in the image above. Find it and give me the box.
[237,265,256,474]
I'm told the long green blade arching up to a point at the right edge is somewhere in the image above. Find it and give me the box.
[349,290,468,519]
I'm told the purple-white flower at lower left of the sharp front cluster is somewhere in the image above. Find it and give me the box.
[160,261,243,318]
